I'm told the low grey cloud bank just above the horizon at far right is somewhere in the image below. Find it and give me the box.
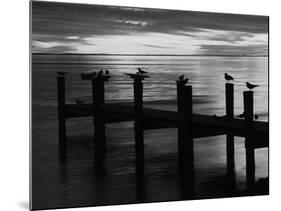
[197,44,268,56]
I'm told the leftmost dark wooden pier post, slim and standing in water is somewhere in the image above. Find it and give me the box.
[57,76,66,158]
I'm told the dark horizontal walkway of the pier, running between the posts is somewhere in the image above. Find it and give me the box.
[61,104,269,147]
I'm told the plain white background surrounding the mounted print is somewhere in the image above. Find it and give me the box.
[0,0,281,211]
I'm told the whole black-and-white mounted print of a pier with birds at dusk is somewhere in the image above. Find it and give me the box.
[30,1,269,210]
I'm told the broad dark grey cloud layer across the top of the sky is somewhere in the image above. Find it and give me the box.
[32,2,268,37]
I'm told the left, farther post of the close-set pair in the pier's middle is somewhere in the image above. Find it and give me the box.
[176,80,185,171]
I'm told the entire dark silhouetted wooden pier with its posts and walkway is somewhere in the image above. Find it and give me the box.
[57,75,269,187]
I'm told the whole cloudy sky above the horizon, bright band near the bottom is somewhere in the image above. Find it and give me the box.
[32,1,268,56]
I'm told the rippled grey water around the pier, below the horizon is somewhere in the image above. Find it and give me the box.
[32,55,268,207]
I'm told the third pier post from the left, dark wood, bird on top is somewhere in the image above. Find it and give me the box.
[134,76,144,176]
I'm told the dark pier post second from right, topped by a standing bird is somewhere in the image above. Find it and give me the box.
[225,83,235,178]
